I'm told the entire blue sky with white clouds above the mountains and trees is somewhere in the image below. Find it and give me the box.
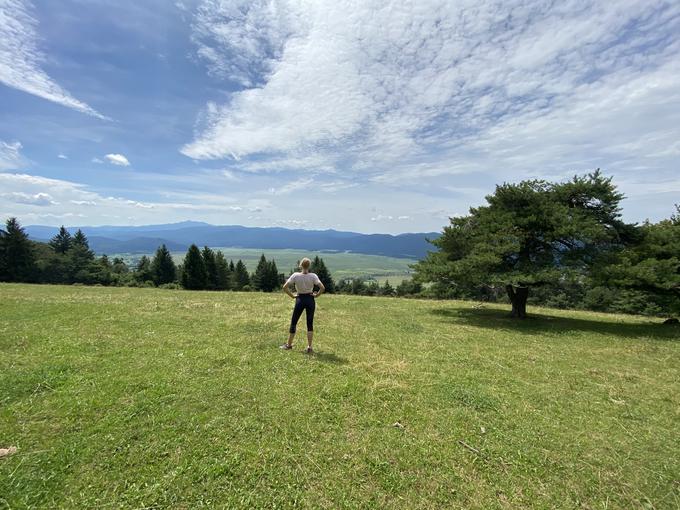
[0,0,680,233]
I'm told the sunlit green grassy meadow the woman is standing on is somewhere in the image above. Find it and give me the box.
[0,284,680,509]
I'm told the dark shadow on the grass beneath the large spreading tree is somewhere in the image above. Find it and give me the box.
[432,308,680,340]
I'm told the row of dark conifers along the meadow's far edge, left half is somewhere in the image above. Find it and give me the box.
[0,218,335,293]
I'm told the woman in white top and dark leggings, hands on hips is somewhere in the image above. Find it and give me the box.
[281,257,326,354]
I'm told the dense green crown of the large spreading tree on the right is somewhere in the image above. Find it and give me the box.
[415,170,633,315]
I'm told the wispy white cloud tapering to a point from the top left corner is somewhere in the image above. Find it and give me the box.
[0,0,107,119]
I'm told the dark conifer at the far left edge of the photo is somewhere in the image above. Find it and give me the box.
[0,218,37,282]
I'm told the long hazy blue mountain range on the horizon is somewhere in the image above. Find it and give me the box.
[26,221,439,259]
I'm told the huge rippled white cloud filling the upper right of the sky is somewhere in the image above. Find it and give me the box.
[182,0,680,223]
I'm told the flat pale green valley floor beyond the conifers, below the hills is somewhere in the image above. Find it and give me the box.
[109,248,416,285]
